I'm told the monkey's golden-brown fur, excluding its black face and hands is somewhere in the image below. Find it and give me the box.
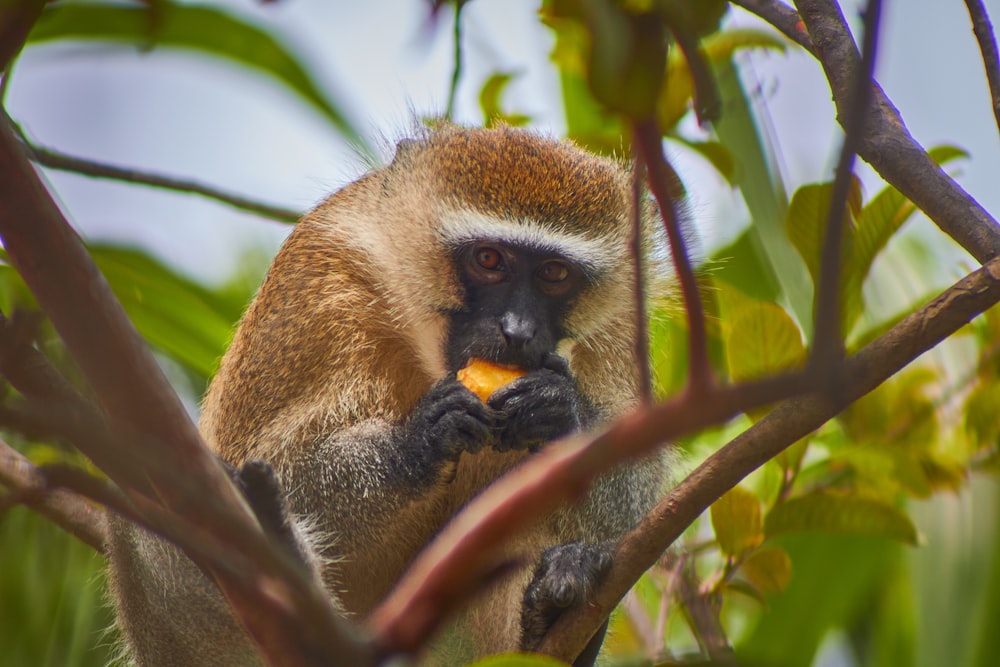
[112,127,662,665]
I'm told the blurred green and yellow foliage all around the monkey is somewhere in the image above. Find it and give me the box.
[0,0,1000,667]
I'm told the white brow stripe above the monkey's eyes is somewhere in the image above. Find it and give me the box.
[438,211,621,276]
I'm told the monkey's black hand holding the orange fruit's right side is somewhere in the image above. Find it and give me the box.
[488,354,581,452]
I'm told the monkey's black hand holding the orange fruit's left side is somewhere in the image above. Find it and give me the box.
[401,377,497,482]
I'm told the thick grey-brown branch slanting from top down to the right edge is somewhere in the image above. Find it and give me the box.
[738,0,1000,262]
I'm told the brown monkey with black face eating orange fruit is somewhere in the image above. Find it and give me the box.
[109,125,667,666]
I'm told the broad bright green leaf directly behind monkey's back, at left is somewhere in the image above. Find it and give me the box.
[90,246,239,379]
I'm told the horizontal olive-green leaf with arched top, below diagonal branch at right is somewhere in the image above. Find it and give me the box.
[764,492,919,545]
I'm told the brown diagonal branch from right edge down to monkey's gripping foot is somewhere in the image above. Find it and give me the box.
[540,253,1000,658]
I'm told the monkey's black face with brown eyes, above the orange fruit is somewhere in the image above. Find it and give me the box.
[447,241,586,371]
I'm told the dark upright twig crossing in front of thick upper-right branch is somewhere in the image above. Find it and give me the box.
[810,0,882,379]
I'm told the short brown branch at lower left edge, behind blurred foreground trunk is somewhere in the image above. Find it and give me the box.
[0,440,107,554]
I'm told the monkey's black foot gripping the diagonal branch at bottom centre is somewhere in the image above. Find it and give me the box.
[521,542,613,665]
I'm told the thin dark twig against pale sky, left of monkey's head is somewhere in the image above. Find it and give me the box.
[15,126,302,222]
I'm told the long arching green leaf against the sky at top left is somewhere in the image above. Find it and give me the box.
[28,0,361,147]
